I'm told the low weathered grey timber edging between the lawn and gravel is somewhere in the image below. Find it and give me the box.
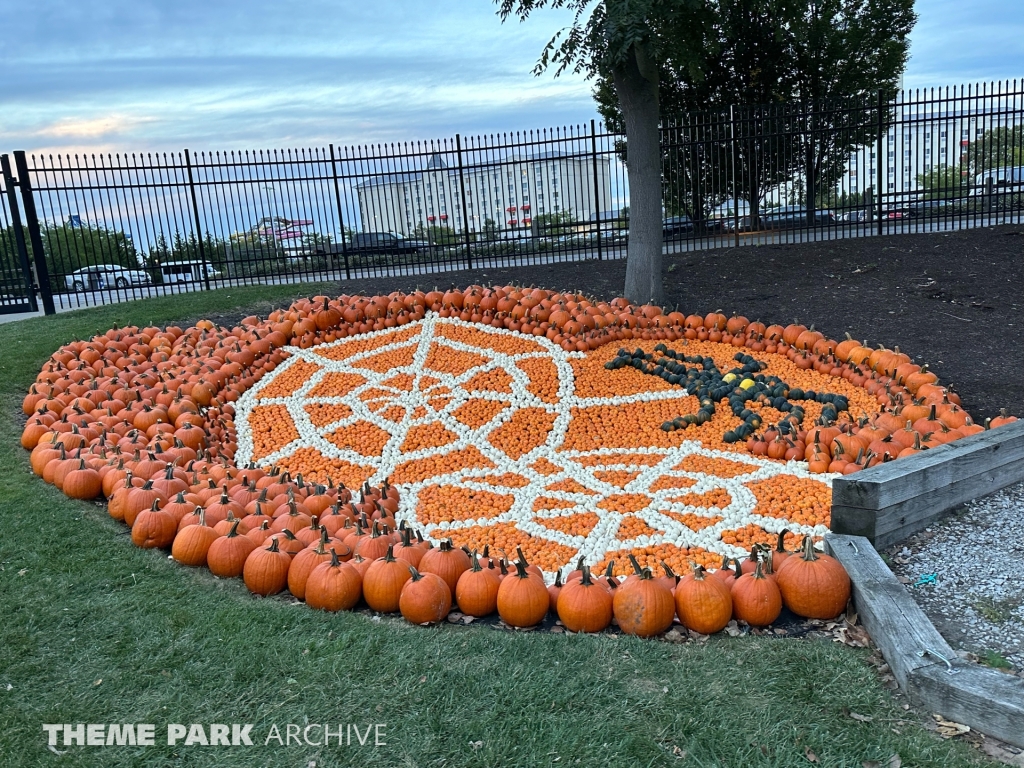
[825,536,1024,746]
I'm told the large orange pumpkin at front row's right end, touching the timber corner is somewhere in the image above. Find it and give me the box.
[776,537,850,620]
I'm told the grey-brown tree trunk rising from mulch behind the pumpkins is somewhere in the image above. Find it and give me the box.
[612,45,664,304]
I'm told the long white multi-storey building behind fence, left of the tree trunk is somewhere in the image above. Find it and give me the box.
[355,153,611,234]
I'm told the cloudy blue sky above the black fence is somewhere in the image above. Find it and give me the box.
[0,0,1024,153]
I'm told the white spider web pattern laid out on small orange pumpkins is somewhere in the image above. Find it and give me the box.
[236,313,831,581]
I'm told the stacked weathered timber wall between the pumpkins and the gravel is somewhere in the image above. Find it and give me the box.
[831,420,1024,549]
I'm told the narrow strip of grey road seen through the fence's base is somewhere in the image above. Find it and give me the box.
[0,213,1024,323]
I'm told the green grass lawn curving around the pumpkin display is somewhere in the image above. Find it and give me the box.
[0,286,984,768]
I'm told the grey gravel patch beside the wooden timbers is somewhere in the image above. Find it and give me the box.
[888,483,1024,671]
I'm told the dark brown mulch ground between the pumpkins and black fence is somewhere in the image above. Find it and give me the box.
[201,225,1024,420]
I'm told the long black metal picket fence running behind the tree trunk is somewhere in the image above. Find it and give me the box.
[0,81,1024,313]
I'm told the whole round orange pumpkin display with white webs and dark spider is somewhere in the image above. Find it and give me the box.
[22,286,991,634]
